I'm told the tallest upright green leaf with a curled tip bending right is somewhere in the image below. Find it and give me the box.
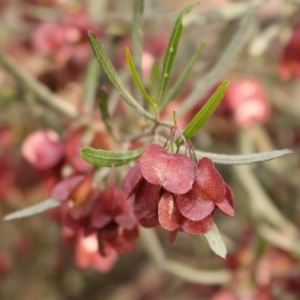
[158,3,198,103]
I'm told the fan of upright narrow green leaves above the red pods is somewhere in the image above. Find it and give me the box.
[89,4,203,120]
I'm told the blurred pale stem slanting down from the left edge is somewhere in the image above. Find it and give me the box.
[0,51,78,118]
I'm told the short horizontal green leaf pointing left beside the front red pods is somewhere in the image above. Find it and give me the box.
[80,147,144,168]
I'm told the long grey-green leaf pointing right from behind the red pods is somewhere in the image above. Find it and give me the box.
[195,149,293,165]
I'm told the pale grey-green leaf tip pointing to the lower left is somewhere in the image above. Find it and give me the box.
[3,198,62,221]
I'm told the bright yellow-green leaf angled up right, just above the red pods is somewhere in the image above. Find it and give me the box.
[183,80,229,139]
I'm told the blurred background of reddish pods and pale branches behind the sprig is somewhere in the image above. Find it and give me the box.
[0,0,300,300]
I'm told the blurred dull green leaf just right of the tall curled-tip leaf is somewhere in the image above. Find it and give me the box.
[160,43,204,111]
